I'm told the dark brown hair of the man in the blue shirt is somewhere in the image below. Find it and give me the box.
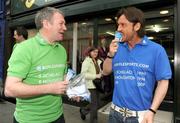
[117,7,145,37]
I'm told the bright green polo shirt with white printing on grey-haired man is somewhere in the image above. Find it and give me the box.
[8,33,67,123]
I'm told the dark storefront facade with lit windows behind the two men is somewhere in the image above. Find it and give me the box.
[4,0,180,123]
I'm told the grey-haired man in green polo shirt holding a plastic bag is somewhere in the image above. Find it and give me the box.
[5,7,78,123]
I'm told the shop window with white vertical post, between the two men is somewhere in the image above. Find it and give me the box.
[62,20,93,73]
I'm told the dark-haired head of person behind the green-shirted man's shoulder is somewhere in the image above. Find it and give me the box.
[13,26,28,49]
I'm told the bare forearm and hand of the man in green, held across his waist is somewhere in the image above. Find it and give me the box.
[5,76,68,98]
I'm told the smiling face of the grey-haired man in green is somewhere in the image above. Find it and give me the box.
[48,13,67,41]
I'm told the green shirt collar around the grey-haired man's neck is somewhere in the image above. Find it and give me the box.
[35,33,60,47]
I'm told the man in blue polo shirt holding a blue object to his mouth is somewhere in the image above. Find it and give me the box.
[103,7,172,123]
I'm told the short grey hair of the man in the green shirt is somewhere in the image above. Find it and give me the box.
[35,7,64,30]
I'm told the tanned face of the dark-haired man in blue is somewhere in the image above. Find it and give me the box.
[117,15,137,41]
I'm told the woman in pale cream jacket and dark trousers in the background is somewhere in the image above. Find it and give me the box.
[80,47,102,123]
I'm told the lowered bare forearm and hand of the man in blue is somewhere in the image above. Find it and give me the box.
[142,80,169,123]
